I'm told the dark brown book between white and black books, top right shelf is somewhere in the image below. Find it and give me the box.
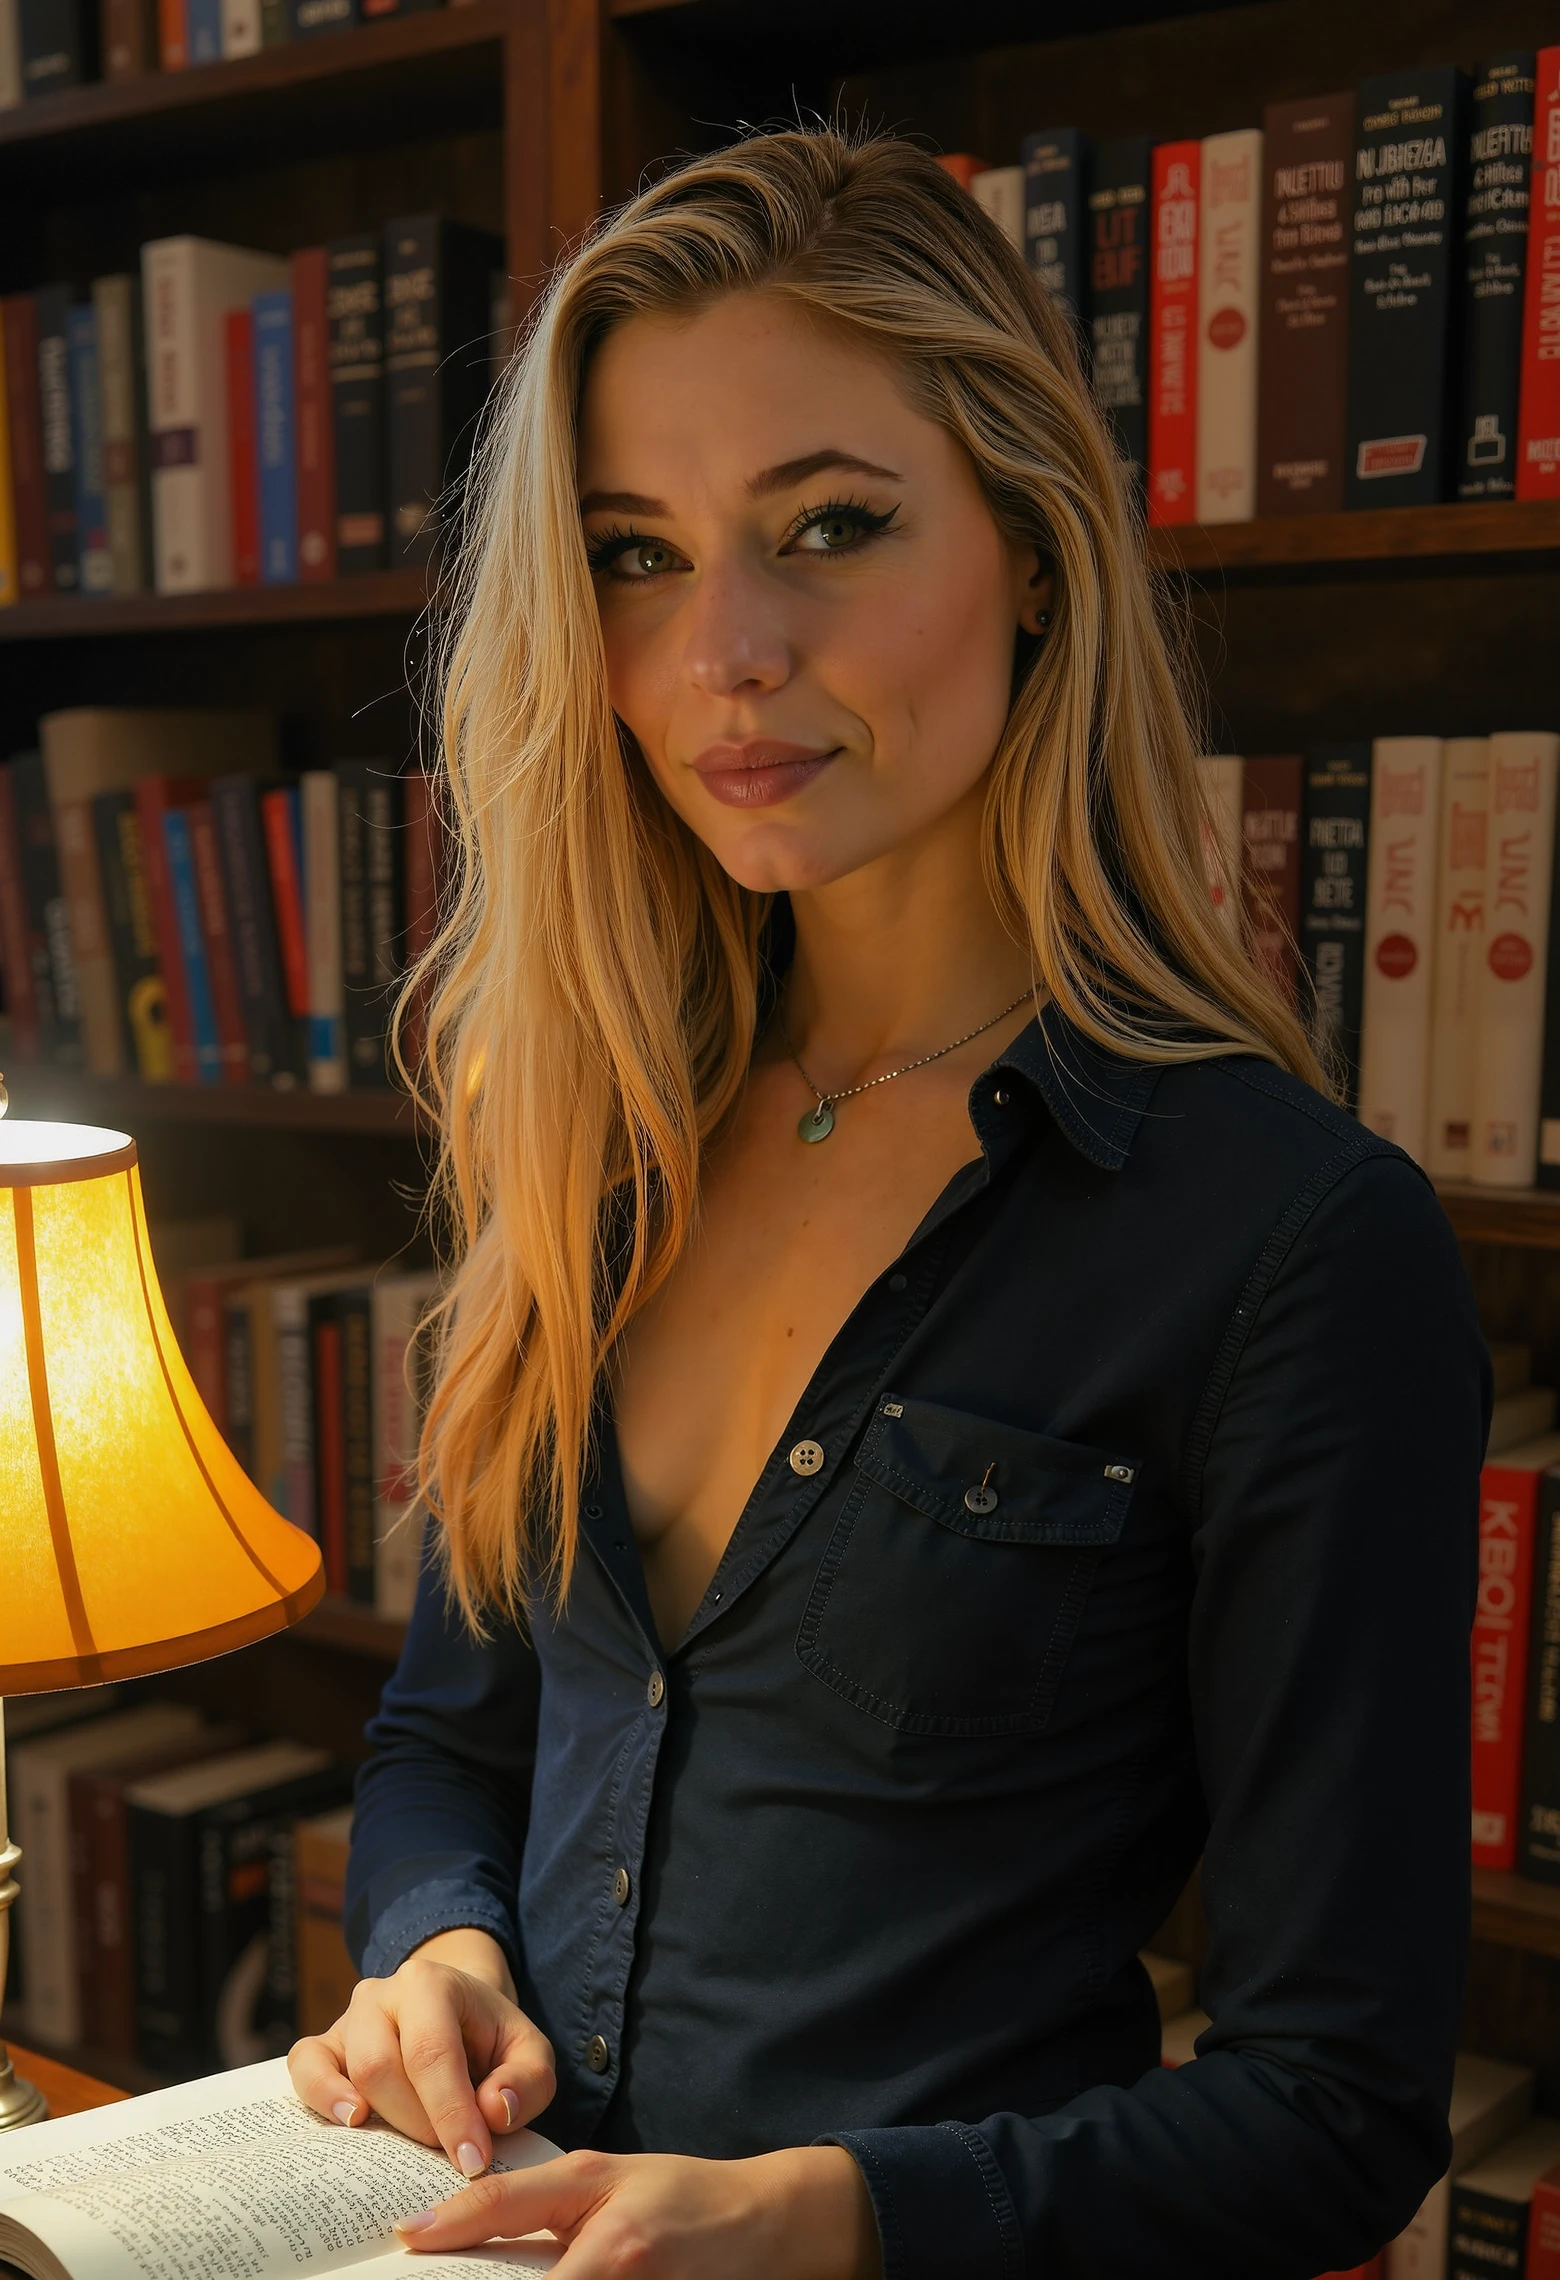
[1257,93,1355,515]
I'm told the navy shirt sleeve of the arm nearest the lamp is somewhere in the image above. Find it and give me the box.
[347,1562,541,1977]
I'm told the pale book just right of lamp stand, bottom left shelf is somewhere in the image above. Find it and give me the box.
[7,1703,201,2045]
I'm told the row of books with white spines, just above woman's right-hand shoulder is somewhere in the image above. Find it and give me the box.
[1202,732,1560,1188]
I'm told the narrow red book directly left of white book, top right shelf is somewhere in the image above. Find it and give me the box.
[1147,141,1202,524]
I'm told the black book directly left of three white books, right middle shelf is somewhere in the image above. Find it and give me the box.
[1300,743,1371,1110]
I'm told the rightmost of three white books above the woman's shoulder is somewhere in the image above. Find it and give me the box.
[1471,732,1560,1188]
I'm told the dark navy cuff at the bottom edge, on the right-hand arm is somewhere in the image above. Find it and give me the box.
[816,2123,1024,2280]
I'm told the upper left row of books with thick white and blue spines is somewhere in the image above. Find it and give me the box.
[0,214,509,602]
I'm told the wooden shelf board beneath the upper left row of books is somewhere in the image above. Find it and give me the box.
[0,570,429,641]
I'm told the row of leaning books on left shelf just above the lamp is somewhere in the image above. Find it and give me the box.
[0,707,445,1092]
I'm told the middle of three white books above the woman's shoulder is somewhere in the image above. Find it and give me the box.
[1428,736,1489,1179]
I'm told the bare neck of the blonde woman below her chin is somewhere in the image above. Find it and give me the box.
[785,784,1031,1083]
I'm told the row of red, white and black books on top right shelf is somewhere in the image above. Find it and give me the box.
[944,48,1560,524]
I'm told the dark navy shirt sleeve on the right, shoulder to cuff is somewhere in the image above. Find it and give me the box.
[835,1154,1489,2280]
